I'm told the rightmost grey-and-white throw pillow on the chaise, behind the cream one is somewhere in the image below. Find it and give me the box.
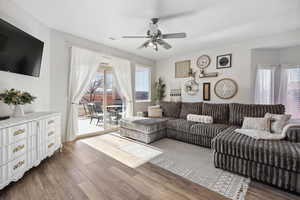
[265,113,291,134]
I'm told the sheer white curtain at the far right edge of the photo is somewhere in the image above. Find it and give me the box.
[279,65,300,119]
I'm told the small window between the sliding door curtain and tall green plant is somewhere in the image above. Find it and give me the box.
[135,66,151,101]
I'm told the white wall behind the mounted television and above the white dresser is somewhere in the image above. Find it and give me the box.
[0,0,50,116]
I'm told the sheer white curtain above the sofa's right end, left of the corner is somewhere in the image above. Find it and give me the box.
[254,65,278,104]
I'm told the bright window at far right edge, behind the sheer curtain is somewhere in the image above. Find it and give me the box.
[286,67,300,119]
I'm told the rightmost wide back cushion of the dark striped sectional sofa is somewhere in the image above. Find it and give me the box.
[229,103,285,126]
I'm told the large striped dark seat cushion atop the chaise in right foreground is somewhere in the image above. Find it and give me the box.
[212,127,300,172]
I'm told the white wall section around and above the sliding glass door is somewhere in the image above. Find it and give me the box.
[50,30,155,139]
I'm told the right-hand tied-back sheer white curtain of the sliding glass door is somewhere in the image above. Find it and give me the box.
[111,58,134,117]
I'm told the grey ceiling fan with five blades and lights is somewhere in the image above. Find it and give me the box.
[123,18,186,51]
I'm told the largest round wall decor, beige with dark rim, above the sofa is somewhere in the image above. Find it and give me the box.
[215,78,238,99]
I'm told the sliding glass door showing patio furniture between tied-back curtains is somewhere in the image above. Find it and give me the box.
[78,67,123,135]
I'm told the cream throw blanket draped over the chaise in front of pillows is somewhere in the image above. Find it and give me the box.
[235,124,300,140]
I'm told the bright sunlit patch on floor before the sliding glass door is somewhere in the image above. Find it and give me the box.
[81,133,162,168]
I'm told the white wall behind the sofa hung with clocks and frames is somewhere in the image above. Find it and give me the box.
[156,30,300,103]
